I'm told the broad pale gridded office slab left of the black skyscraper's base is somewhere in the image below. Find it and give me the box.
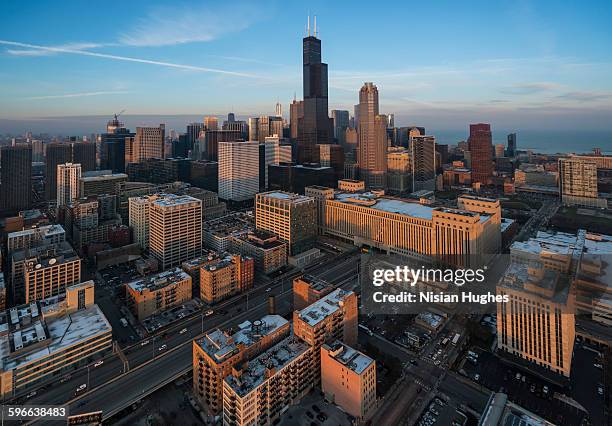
[219,142,259,201]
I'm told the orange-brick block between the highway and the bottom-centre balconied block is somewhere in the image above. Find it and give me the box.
[193,315,290,415]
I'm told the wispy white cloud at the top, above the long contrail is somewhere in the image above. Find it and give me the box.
[119,3,261,46]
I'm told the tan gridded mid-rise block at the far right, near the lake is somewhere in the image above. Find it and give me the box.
[559,156,607,208]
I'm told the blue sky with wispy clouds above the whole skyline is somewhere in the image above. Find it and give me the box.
[0,0,612,133]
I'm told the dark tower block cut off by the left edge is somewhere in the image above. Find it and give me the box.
[0,144,32,212]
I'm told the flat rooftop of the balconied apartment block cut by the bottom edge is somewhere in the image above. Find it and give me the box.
[225,336,310,397]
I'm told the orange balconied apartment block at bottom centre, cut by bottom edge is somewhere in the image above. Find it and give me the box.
[223,337,316,425]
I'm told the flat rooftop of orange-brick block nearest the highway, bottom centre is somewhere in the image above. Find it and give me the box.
[196,315,289,363]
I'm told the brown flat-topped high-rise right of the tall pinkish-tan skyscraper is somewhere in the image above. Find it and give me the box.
[410,136,436,191]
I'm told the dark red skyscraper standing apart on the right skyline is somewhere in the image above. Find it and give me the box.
[468,123,493,185]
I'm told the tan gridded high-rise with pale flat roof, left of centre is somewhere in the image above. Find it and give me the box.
[149,194,202,269]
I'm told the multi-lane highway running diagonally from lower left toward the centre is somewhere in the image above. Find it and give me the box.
[21,254,359,424]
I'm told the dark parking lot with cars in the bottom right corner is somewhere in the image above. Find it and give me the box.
[460,349,592,424]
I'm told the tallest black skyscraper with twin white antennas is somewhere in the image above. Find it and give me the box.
[298,17,333,163]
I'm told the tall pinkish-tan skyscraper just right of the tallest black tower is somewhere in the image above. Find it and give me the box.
[358,83,387,188]
